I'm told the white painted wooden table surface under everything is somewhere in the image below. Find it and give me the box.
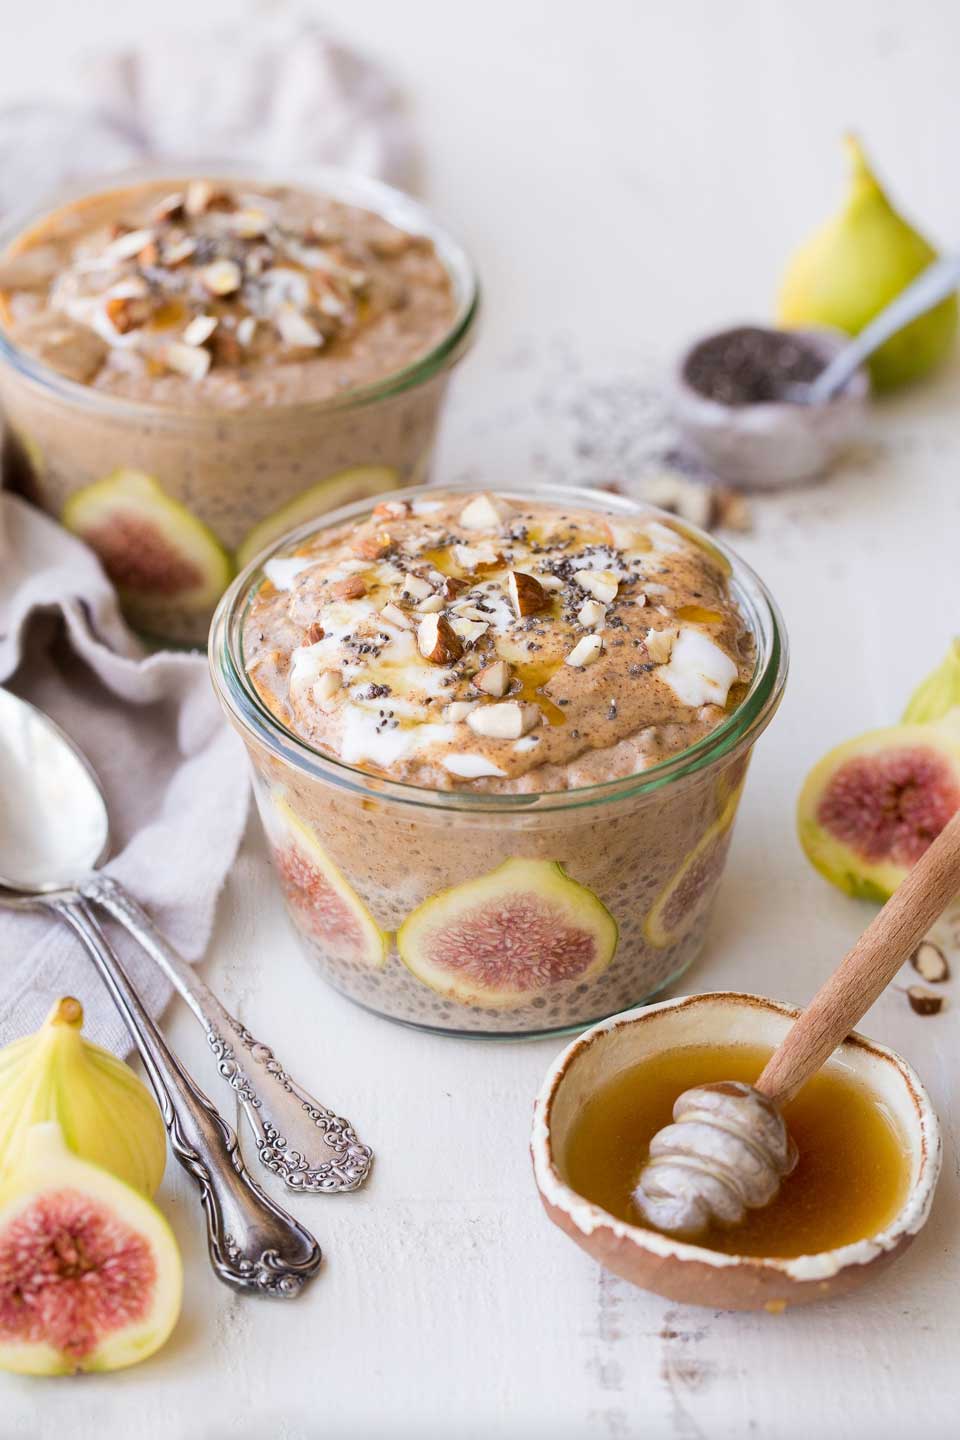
[7,0,960,1440]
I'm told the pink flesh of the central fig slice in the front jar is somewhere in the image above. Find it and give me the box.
[425,894,597,994]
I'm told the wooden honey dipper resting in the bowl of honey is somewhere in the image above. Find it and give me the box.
[633,811,960,1237]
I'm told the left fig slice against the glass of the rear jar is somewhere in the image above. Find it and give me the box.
[62,469,233,635]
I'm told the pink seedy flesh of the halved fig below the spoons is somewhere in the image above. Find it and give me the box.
[0,1189,157,1361]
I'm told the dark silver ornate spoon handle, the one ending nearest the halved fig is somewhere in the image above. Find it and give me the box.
[51,897,321,1297]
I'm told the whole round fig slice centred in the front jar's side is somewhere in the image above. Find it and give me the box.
[397,860,619,1009]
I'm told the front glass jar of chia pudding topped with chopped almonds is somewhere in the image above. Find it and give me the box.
[210,488,786,1037]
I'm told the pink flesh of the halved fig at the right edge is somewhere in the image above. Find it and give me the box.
[816,746,960,868]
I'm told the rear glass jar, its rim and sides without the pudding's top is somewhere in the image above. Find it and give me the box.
[0,164,479,644]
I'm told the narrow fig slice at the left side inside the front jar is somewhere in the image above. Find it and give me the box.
[268,796,390,971]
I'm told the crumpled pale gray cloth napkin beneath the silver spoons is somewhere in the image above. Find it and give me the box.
[0,494,249,1054]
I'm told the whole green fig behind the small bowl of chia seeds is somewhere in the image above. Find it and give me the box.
[777,135,957,390]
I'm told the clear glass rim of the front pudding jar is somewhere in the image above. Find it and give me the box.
[209,482,789,815]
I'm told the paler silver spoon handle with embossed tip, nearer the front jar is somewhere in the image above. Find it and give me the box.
[79,874,373,1195]
